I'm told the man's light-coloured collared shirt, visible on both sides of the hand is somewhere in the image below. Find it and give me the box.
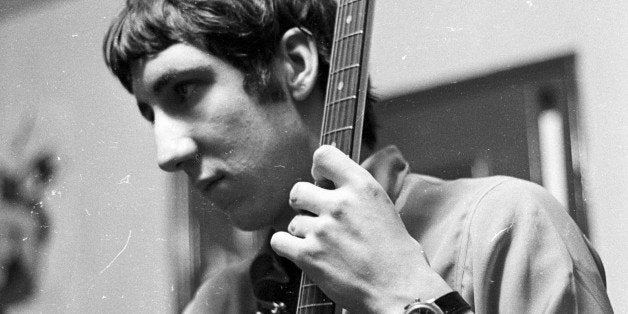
[186,147,612,313]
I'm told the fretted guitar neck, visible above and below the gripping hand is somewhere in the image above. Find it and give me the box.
[297,0,374,314]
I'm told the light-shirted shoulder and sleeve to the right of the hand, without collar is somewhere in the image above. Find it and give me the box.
[402,175,608,313]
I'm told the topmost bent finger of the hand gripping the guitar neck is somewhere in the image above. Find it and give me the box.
[312,145,368,187]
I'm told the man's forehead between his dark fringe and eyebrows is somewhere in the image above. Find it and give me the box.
[131,43,234,96]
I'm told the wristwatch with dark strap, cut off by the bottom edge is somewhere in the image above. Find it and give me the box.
[403,291,471,314]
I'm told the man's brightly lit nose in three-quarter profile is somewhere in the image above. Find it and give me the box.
[154,113,198,172]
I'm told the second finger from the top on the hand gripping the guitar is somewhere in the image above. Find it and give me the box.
[290,182,336,216]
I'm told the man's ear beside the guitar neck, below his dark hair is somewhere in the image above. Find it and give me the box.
[280,27,318,101]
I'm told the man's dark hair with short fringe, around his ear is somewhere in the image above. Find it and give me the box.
[103,0,375,148]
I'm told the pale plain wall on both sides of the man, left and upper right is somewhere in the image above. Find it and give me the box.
[0,0,628,313]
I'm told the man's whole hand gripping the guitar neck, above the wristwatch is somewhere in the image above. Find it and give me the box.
[271,146,451,313]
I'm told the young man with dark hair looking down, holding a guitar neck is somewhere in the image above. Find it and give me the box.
[104,0,612,313]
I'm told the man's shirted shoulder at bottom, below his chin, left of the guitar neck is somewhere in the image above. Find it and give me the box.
[184,260,255,314]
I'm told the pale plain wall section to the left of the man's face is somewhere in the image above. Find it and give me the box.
[0,0,174,313]
